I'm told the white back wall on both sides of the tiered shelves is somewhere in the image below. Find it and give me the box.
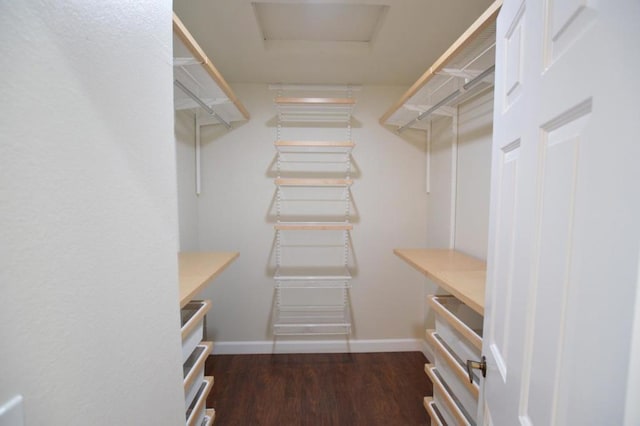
[190,85,426,352]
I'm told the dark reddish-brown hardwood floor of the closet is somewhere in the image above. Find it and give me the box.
[205,352,432,426]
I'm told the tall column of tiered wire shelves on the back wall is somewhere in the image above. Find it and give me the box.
[272,88,355,336]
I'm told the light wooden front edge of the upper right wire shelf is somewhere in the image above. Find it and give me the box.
[378,0,503,126]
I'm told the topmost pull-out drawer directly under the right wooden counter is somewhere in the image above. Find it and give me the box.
[427,296,483,359]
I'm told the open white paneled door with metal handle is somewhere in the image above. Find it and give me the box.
[478,0,640,426]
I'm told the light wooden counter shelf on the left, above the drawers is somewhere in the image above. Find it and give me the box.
[178,252,240,308]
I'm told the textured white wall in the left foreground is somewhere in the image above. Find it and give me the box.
[0,1,184,426]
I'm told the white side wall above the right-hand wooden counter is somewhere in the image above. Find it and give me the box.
[427,90,493,259]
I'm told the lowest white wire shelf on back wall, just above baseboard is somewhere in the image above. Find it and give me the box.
[273,305,351,336]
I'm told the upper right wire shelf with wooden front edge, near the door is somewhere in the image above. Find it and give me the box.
[380,0,502,130]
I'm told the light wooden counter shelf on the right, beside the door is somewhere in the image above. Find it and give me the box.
[393,249,487,315]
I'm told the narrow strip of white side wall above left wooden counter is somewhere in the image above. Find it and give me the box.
[175,110,198,251]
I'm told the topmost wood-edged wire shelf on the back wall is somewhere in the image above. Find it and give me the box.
[274,96,356,123]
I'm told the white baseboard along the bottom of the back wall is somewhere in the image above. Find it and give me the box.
[213,338,432,359]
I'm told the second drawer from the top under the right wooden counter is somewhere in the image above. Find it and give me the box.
[427,330,480,415]
